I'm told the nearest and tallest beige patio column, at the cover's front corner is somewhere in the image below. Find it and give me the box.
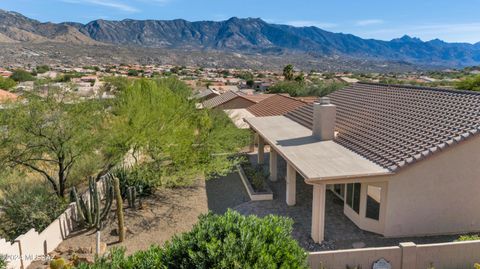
[312,184,326,243]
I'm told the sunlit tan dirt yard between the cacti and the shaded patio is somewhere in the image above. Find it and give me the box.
[29,180,208,268]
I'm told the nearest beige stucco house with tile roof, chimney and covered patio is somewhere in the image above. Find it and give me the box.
[245,83,480,242]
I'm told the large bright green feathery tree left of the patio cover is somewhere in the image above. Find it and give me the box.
[109,78,248,186]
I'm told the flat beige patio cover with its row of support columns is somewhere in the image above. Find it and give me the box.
[245,113,389,243]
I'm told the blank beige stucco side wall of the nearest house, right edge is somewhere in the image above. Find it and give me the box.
[384,136,480,236]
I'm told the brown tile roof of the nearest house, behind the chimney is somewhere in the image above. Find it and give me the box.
[285,83,480,171]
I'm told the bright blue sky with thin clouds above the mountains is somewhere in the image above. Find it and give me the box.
[0,0,480,43]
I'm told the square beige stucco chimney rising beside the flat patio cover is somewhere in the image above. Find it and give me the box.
[313,97,337,141]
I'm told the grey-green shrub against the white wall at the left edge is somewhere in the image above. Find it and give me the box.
[0,183,66,240]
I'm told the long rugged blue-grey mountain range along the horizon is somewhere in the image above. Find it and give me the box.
[0,10,480,67]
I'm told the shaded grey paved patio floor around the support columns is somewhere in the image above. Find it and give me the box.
[234,152,464,251]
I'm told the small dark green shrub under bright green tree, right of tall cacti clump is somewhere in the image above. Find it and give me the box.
[113,167,156,198]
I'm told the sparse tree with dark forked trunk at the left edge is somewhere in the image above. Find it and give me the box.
[0,90,103,197]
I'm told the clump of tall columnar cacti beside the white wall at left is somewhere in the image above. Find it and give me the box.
[72,176,114,230]
